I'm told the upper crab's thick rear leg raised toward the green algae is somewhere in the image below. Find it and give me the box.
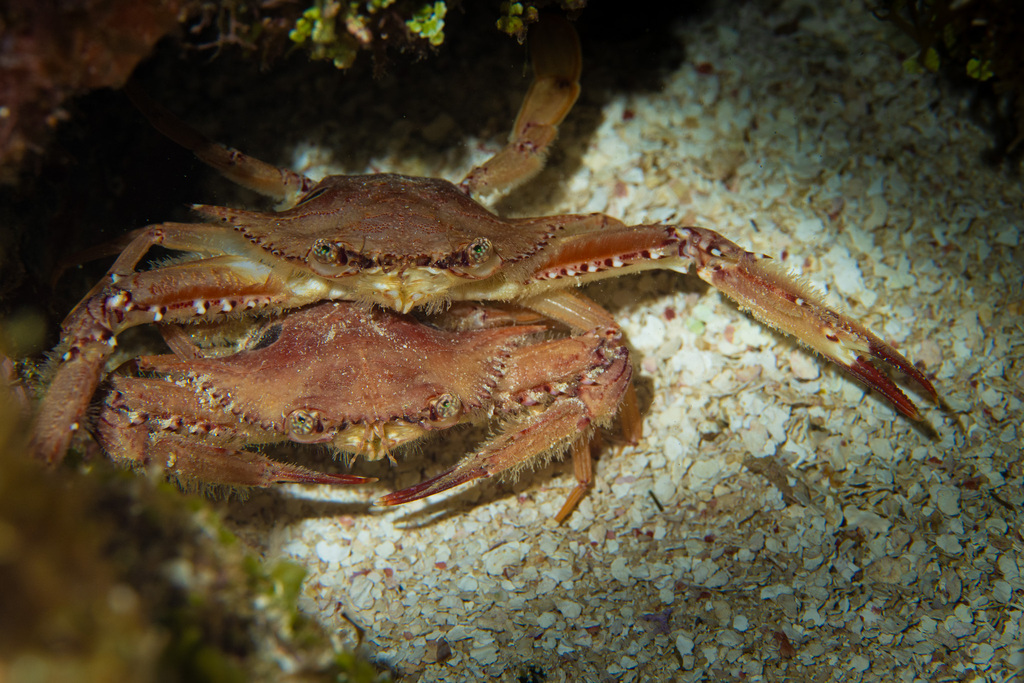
[461,16,582,195]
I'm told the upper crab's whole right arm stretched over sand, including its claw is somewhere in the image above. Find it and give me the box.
[516,216,938,420]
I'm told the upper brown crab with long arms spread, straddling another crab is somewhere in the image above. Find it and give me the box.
[33,18,936,507]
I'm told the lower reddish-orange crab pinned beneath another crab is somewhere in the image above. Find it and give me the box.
[96,302,639,520]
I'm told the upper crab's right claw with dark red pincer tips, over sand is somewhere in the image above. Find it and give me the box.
[680,227,938,420]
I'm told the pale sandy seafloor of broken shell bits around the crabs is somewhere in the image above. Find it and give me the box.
[22,2,1024,683]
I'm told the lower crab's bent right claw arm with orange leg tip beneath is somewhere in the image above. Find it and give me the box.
[378,328,633,521]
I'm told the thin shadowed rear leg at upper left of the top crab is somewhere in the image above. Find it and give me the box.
[124,81,315,207]
